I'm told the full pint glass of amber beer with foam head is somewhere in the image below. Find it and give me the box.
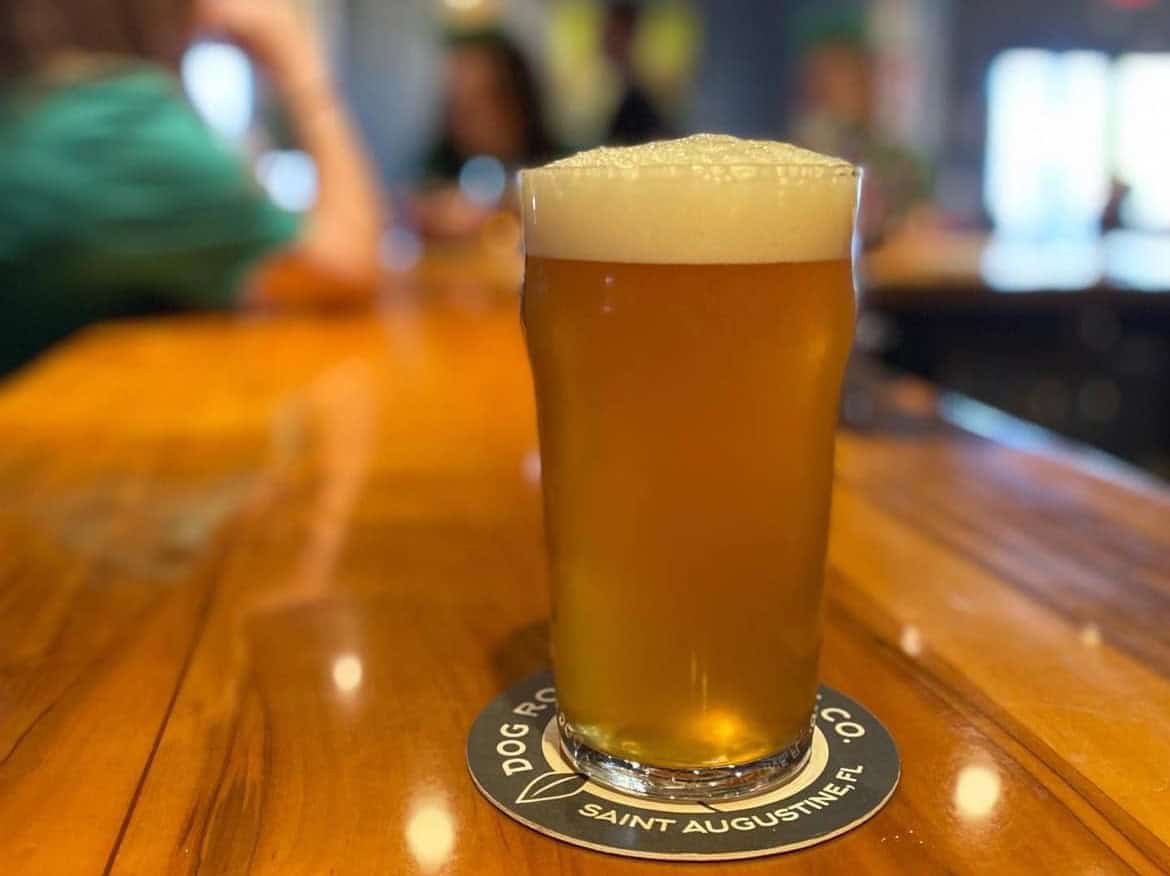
[521,134,860,800]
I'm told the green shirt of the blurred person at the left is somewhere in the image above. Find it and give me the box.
[0,65,297,373]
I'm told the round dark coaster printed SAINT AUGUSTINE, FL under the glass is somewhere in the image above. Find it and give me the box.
[467,672,901,861]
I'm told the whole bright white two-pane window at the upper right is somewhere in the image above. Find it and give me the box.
[984,49,1170,232]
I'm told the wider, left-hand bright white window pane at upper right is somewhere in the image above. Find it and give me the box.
[984,49,1110,237]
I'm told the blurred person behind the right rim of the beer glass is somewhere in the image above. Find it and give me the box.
[794,20,931,246]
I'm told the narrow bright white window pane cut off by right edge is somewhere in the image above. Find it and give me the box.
[1114,54,1170,230]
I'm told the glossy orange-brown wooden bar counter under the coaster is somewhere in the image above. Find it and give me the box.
[0,277,1170,876]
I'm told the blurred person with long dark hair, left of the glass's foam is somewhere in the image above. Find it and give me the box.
[412,32,555,237]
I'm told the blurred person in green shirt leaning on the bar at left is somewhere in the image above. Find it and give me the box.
[0,0,381,373]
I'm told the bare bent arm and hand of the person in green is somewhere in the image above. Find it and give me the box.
[200,0,384,305]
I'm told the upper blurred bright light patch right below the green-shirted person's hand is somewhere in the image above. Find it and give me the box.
[180,42,256,143]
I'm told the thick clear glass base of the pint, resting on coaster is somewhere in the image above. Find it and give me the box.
[557,712,812,802]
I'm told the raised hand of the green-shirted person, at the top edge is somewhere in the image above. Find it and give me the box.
[197,0,328,89]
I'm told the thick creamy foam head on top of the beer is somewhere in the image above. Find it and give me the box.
[521,133,859,264]
